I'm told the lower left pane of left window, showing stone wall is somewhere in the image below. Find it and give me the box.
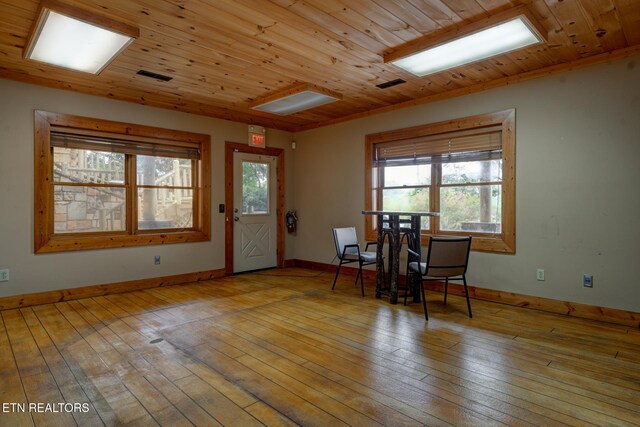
[53,185,127,233]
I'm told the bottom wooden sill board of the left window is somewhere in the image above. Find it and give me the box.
[35,231,210,254]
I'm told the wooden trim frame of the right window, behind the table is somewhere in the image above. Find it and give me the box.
[364,109,516,254]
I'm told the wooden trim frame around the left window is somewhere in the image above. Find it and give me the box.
[34,110,211,254]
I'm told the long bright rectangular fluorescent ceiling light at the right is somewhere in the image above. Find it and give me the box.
[385,6,544,77]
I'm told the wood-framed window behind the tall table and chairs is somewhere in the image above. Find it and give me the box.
[365,110,515,253]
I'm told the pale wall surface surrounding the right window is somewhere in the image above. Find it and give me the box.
[294,56,640,312]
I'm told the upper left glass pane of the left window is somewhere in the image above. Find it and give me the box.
[53,147,124,184]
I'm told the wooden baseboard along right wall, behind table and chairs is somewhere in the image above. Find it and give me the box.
[295,259,640,328]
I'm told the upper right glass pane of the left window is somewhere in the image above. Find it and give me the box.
[136,156,192,187]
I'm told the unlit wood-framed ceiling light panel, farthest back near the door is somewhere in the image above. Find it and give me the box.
[249,83,342,116]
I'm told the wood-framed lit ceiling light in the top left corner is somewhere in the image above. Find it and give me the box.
[24,0,140,74]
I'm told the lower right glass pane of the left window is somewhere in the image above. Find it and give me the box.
[138,188,193,230]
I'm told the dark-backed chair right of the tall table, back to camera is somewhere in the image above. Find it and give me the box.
[404,236,473,320]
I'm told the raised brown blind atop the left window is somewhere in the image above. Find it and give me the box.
[51,131,200,160]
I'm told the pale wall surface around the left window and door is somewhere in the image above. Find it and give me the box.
[0,79,295,296]
